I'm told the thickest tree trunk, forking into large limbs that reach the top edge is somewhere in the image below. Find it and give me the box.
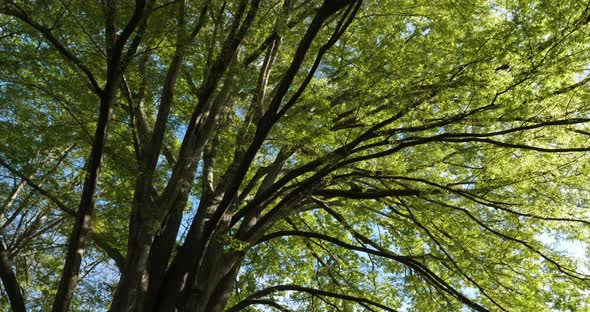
[113,1,350,312]
